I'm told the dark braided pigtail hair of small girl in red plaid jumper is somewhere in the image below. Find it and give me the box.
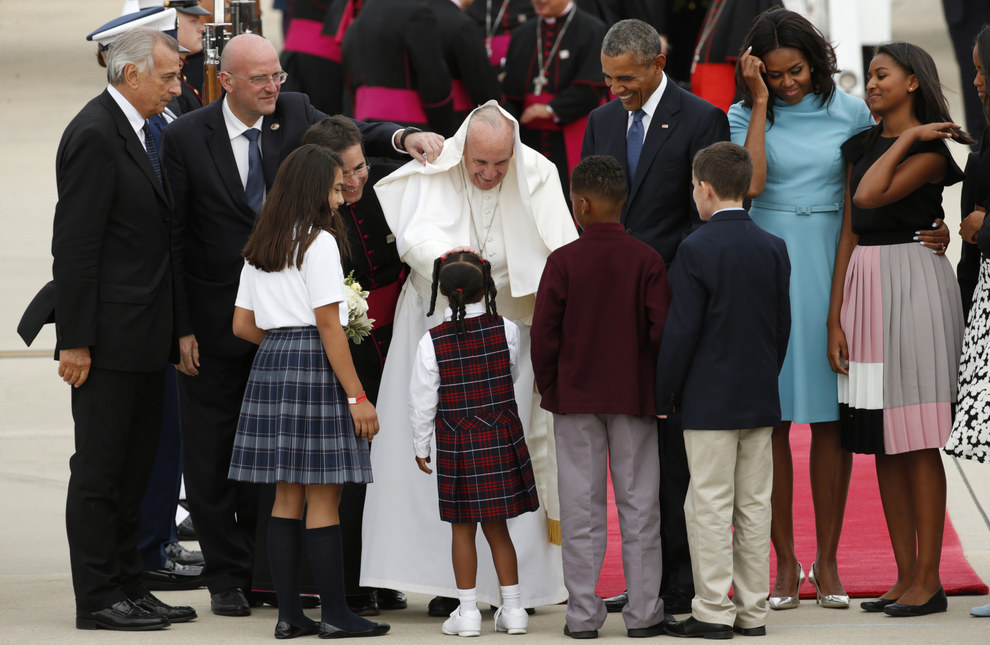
[426,251,498,336]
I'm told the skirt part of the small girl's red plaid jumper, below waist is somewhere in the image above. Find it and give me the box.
[436,410,540,522]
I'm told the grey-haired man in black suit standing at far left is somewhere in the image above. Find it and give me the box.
[52,28,196,630]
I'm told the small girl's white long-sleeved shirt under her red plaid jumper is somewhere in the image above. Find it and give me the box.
[409,296,519,459]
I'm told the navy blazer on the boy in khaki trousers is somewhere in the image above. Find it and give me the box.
[656,209,796,430]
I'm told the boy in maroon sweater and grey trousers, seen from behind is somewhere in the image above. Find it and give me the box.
[530,156,670,638]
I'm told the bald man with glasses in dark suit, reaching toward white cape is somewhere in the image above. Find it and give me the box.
[162,34,442,616]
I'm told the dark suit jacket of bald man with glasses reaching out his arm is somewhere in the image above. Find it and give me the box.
[162,92,399,356]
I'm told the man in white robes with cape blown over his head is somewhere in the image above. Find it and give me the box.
[361,101,577,607]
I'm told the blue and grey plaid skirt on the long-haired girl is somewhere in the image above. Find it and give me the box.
[227,327,371,484]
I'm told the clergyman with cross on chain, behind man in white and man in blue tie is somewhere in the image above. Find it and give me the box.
[502,0,607,195]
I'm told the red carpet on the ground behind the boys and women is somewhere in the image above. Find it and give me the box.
[598,424,988,598]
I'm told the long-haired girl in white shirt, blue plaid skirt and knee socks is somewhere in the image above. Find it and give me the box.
[229,145,389,639]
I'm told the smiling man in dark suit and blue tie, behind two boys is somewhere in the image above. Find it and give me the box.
[581,20,729,613]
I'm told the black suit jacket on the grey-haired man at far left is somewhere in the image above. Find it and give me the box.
[49,91,174,372]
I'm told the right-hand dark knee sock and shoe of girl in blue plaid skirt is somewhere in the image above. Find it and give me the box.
[306,524,375,632]
